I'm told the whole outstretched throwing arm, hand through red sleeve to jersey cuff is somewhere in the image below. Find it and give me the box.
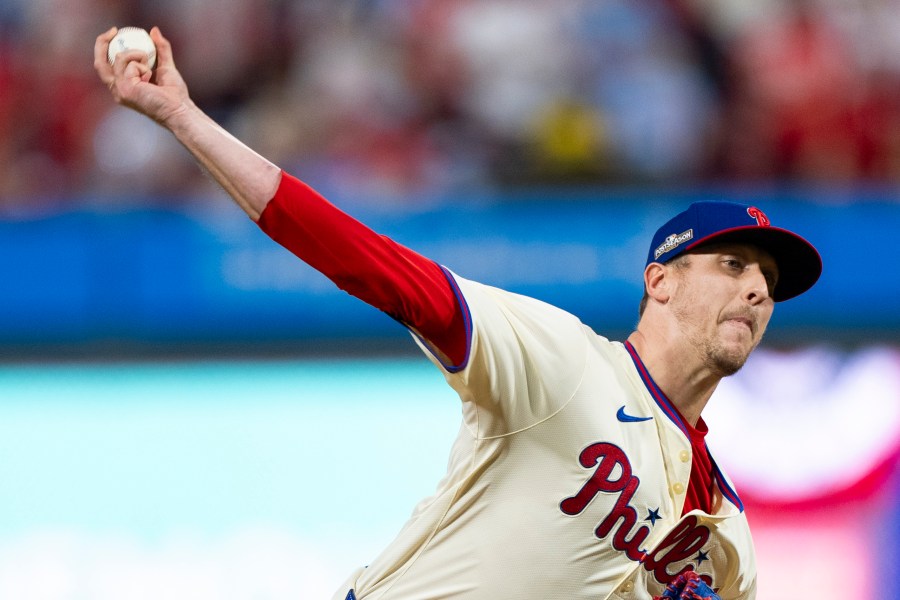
[94,27,468,367]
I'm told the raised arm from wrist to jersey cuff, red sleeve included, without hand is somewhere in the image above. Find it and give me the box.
[162,103,465,364]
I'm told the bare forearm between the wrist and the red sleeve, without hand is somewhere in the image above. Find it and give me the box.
[163,104,281,221]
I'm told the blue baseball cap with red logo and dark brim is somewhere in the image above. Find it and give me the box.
[647,202,822,302]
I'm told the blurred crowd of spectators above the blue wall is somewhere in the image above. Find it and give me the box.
[0,0,900,211]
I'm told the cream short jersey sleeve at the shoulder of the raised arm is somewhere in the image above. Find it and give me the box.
[419,273,588,438]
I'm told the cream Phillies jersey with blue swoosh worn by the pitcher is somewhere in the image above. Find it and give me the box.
[335,276,756,600]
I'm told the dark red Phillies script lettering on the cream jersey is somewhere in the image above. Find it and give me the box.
[559,442,712,585]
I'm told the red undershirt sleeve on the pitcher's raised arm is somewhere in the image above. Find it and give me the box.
[258,172,468,367]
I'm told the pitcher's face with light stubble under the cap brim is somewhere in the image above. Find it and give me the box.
[670,244,778,376]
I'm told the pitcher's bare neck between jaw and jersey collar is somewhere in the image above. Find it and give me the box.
[628,325,722,427]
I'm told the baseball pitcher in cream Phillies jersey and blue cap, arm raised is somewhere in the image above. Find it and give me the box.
[95,28,822,600]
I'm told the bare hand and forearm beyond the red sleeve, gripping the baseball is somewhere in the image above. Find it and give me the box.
[94,27,281,221]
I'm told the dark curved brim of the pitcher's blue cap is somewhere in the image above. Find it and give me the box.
[685,226,822,302]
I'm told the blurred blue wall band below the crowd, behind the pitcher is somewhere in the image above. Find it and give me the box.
[0,190,900,353]
